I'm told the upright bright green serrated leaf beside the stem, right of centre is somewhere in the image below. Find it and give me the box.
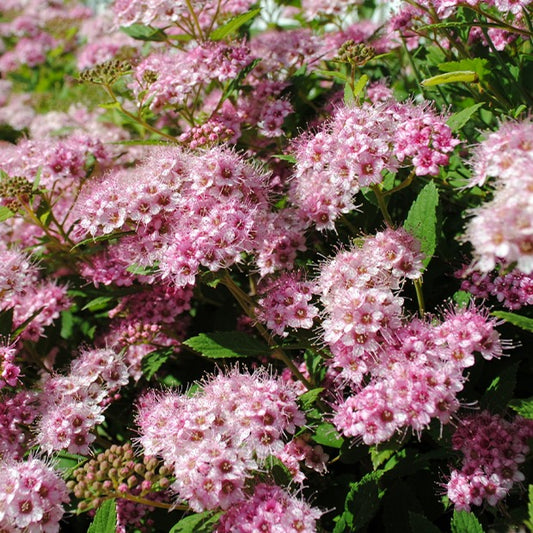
[403,181,439,267]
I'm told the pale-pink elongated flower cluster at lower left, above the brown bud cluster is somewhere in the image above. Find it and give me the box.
[37,349,128,454]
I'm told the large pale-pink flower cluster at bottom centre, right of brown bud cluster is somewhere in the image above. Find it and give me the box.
[137,370,305,512]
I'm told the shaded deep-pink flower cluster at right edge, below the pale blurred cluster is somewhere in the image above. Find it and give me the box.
[455,265,533,310]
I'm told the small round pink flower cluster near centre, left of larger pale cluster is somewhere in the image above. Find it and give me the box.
[256,273,318,337]
